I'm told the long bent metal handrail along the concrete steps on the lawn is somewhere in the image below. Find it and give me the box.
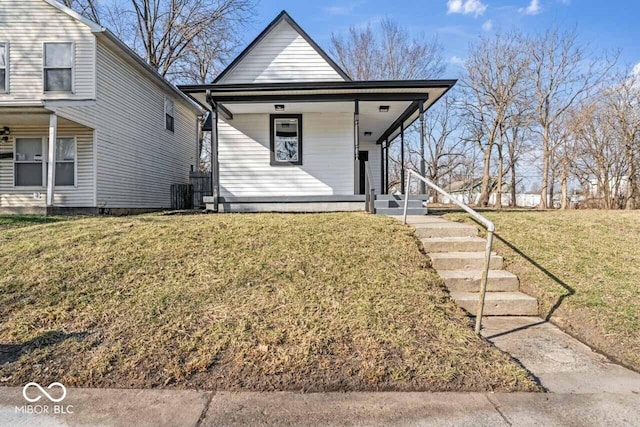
[402,170,496,335]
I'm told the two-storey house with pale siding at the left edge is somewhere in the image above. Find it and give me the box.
[0,0,203,213]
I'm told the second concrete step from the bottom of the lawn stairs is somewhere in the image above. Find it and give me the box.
[438,270,520,292]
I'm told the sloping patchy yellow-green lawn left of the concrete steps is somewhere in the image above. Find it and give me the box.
[0,214,538,391]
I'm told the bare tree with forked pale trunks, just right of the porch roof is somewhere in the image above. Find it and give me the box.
[461,33,529,206]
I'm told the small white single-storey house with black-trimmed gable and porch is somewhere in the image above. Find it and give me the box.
[180,11,455,211]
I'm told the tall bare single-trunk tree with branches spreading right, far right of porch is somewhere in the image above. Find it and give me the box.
[527,28,617,209]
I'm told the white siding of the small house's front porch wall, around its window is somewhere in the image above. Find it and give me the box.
[218,113,354,197]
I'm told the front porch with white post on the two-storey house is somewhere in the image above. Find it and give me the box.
[0,104,95,214]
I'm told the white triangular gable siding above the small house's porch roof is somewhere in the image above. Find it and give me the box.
[219,21,344,83]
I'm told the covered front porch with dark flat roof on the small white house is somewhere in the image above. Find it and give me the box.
[181,80,455,213]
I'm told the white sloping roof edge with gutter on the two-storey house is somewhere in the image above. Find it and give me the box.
[42,0,202,113]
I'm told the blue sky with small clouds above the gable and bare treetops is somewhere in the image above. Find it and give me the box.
[252,0,640,77]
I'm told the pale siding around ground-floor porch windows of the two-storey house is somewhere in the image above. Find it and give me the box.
[0,124,94,208]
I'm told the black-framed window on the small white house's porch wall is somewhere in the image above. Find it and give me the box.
[270,114,302,166]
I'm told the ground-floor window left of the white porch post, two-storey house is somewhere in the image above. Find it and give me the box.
[13,138,44,187]
